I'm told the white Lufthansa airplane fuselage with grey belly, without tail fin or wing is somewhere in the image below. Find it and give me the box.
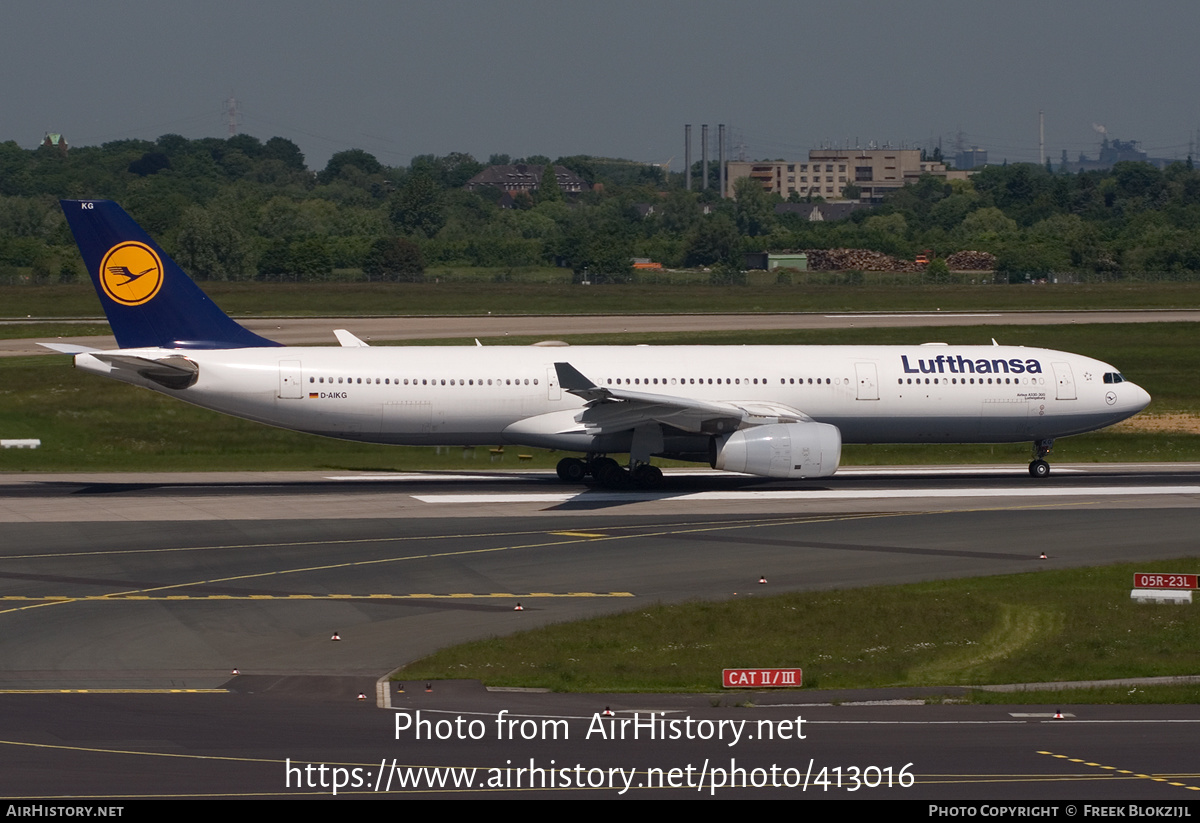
[76,344,1150,465]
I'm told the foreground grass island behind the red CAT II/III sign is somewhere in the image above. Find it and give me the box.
[395,558,1200,702]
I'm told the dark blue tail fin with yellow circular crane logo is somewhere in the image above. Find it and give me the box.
[59,200,278,349]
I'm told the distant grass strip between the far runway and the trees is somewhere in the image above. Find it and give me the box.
[7,276,1200,318]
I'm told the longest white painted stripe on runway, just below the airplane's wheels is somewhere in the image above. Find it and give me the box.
[413,486,1200,503]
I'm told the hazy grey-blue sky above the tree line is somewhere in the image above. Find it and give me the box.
[9,0,1200,170]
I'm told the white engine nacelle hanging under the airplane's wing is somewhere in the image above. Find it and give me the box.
[712,422,841,477]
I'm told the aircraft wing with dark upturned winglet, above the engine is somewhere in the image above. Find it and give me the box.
[554,362,811,434]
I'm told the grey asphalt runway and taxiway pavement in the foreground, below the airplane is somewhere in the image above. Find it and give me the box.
[0,464,1200,804]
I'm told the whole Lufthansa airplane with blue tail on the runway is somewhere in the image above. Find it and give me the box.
[43,200,1150,488]
